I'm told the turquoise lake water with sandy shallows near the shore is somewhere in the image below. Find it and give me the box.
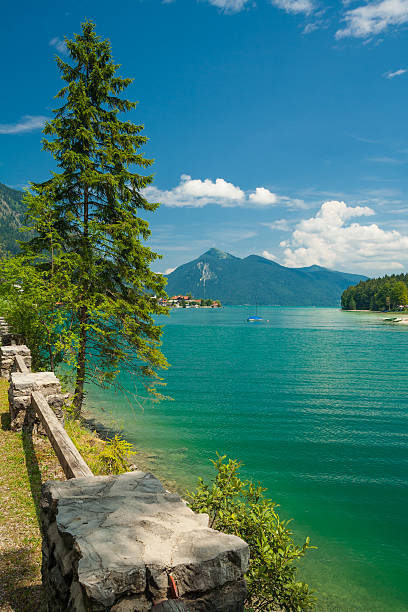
[88,307,408,612]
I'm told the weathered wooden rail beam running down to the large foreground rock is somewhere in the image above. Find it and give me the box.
[31,391,93,478]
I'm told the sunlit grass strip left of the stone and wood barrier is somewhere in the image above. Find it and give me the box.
[0,379,65,612]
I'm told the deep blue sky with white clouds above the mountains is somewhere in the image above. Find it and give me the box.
[0,0,408,275]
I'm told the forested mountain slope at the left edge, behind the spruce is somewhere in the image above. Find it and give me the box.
[0,183,25,253]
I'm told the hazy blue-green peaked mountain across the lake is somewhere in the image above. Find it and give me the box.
[166,249,367,306]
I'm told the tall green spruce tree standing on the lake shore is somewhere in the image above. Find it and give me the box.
[22,21,167,414]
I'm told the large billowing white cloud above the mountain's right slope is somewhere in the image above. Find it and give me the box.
[280,201,408,272]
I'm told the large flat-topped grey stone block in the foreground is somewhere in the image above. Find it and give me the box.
[42,471,249,612]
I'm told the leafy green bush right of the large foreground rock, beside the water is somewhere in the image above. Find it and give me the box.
[188,455,315,612]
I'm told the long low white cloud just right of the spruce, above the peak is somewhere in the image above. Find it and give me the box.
[144,174,298,208]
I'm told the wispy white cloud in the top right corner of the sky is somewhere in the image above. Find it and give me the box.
[336,0,408,39]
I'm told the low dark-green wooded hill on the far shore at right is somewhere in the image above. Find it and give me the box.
[341,274,408,310]
